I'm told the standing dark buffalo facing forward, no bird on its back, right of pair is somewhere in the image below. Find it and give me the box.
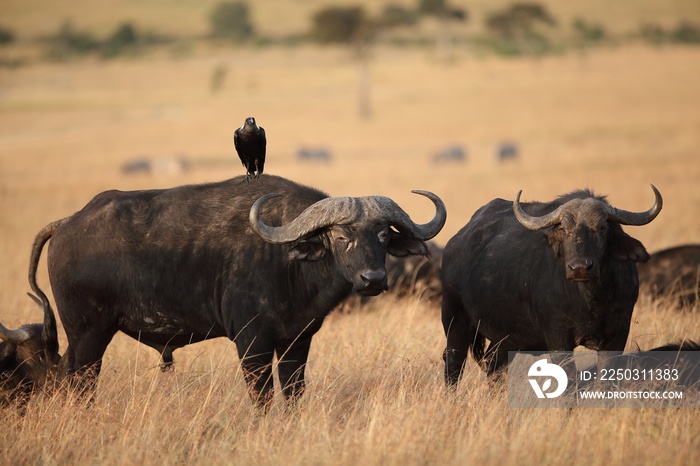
[442,186,663,384]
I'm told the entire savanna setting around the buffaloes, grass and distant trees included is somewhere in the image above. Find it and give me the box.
[0,0,700,464]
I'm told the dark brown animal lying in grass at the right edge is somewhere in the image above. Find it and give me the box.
[637,244,700,306]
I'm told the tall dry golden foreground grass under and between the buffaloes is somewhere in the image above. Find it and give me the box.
[0,301,700,465]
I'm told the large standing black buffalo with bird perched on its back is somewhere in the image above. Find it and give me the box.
[2,175,446,406]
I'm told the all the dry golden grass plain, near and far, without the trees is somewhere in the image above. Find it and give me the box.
[0,35,700,465]
